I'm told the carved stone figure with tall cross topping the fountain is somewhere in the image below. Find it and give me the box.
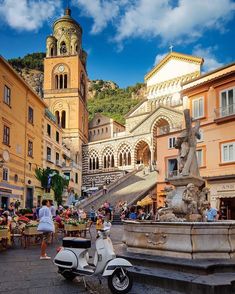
[175,109,200,177]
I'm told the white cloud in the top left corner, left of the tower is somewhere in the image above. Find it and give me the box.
[0,0,61,31]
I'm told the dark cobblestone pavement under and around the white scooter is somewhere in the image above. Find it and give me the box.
[0,226,182,294]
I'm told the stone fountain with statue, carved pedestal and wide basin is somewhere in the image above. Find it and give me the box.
[123,109,235,259]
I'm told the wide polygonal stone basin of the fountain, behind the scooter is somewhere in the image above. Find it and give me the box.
[123,221,235,259]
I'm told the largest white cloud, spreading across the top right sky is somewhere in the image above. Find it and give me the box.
[115,0,235,43]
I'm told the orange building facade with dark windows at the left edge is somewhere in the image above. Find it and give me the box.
[0,57,46,209]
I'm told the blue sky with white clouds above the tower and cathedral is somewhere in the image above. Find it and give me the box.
[0,0,235,87]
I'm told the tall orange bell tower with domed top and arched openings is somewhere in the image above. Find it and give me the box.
[44,8,88,189]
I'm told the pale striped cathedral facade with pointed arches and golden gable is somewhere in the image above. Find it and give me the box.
[83,52,203,189]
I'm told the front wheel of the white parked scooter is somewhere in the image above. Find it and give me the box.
[108,268,133,294]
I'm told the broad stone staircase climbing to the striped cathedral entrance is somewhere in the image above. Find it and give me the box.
[82,170,157,210]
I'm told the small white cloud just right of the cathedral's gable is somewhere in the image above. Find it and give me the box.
[192,45,223,72]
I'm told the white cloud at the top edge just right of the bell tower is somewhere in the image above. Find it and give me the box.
[73,0,121,34]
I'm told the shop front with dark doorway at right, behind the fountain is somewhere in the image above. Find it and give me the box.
[207,177,235,220]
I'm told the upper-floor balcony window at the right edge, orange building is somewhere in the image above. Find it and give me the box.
[220,88,235,116]
